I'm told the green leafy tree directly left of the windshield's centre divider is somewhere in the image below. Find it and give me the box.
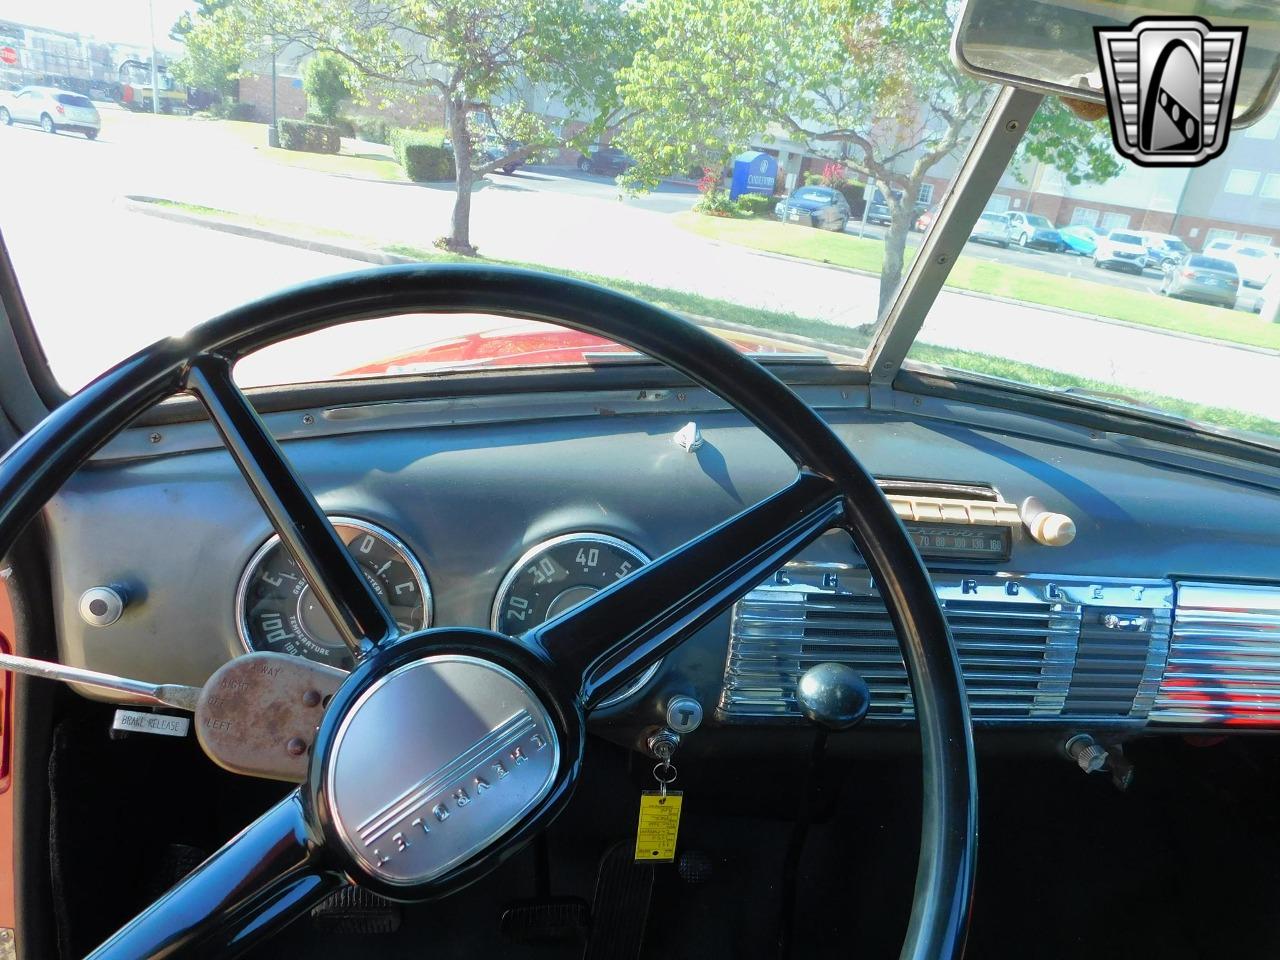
[618,0,1120,312]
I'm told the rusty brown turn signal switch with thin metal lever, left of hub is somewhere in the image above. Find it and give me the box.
[0,653,347,783]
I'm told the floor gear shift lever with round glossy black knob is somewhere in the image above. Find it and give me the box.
[778,663,872,960]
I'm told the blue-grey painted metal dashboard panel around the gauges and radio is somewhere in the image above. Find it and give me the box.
[44,394,1280,710]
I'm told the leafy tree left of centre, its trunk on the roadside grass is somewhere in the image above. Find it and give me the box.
[194,0,630,255]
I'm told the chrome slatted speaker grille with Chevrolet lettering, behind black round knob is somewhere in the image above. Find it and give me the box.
[718,564,1171,722]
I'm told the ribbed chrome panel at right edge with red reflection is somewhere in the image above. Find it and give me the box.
[1151,582,1280,726]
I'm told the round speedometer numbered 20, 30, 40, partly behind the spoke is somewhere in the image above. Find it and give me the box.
[493,534,659,707]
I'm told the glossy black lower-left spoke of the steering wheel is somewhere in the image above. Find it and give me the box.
[88,790,347,960]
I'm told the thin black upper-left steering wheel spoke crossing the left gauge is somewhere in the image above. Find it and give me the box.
[186,353,399,659]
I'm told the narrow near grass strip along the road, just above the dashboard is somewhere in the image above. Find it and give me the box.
[129,200,1280,448]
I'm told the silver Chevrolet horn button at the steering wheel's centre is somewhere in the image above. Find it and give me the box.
[325,654,561,886]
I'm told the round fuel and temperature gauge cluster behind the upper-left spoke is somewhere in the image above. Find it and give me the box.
[236,517,431,669]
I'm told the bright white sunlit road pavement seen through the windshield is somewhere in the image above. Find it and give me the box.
[0,106,1280,419]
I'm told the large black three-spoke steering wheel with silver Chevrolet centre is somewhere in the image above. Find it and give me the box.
[0,265,977,960]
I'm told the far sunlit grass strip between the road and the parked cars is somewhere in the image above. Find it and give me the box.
[676,212,1280,349]
